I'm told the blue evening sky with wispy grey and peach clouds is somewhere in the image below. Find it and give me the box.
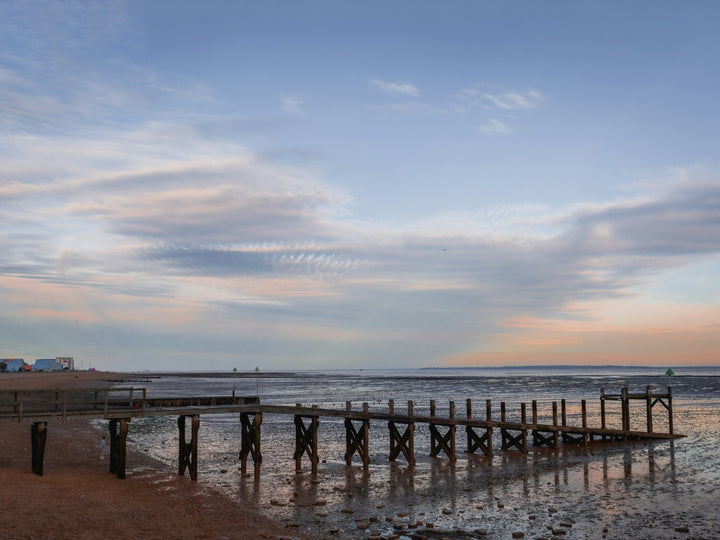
[0,0,720,370]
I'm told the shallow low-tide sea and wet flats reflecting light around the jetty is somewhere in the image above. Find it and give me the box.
[108,366,720,539]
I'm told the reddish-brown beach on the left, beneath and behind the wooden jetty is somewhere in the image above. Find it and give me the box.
[0,372,302,539]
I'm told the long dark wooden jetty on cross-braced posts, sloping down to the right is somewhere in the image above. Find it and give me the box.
[0,387,683,480]
